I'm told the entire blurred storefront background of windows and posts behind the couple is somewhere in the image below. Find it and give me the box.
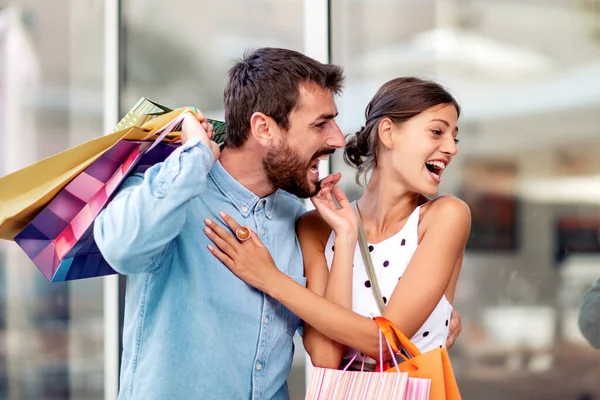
[0,0,600,400]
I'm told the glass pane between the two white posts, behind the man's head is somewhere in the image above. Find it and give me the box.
[120,0,305,399]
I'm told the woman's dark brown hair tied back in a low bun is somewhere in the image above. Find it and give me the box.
[344,77,460,184]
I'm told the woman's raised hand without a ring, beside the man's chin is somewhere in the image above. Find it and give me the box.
[310,172,358,242]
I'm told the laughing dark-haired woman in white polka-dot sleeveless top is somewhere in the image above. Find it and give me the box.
[207,78,470,368]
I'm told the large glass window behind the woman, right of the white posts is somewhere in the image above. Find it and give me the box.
[332,0,600,399]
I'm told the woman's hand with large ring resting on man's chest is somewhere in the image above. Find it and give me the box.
[204,212,282,292]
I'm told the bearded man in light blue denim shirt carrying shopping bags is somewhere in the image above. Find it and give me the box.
[94,48,462,400]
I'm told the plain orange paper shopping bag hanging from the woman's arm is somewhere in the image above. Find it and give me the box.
[374,317,461,400]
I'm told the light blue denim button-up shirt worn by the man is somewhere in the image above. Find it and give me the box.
[94,140,306,400]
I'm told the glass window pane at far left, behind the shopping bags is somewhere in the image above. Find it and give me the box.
[0,0,104,399]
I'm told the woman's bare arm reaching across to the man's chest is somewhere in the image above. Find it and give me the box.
[207,197,471,360]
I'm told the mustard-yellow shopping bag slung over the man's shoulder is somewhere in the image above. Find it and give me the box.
[0,98,171,240]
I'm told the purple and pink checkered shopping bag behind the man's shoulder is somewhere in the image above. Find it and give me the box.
[15,138,179,282]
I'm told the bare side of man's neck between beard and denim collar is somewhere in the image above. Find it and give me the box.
[219,146,275,198]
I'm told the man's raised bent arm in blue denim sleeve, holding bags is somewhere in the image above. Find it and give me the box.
[94,117,218,274]
